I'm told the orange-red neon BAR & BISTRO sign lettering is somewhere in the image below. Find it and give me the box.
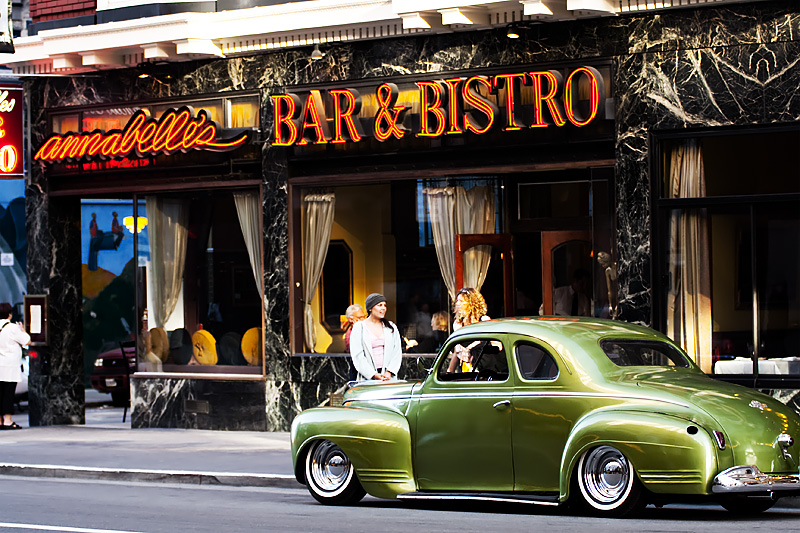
[270,67,605,146]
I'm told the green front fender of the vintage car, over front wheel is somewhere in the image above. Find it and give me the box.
[291,407,416,498]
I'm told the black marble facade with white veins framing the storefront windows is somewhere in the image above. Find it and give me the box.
[26,0,800,430]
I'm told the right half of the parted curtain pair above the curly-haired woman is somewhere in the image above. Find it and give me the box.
[455,186,495,292]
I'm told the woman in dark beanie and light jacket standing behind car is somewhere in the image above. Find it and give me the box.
[350,293,403,381]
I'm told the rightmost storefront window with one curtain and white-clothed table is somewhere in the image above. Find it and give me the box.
[660,133,800,376]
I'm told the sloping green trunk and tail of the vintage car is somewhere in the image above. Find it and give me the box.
[628,369,800,472]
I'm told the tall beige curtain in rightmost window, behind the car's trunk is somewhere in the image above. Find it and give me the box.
[667,140,712,373]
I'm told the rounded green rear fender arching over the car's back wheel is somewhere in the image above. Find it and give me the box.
[559,410,719,501]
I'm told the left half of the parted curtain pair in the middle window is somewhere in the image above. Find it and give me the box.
[424,187,456,301]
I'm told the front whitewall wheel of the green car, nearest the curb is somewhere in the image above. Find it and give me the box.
[306,440,366,505]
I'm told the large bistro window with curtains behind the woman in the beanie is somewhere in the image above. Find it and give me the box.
[299,178,502,353]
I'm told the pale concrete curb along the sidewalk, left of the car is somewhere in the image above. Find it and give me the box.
[0,463,304,489]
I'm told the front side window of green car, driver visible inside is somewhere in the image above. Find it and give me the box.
[437,338,508,381]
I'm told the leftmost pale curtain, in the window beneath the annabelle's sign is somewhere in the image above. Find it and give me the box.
[147,196,189,328]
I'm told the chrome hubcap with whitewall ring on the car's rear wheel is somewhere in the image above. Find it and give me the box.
[581,446,631,504]
